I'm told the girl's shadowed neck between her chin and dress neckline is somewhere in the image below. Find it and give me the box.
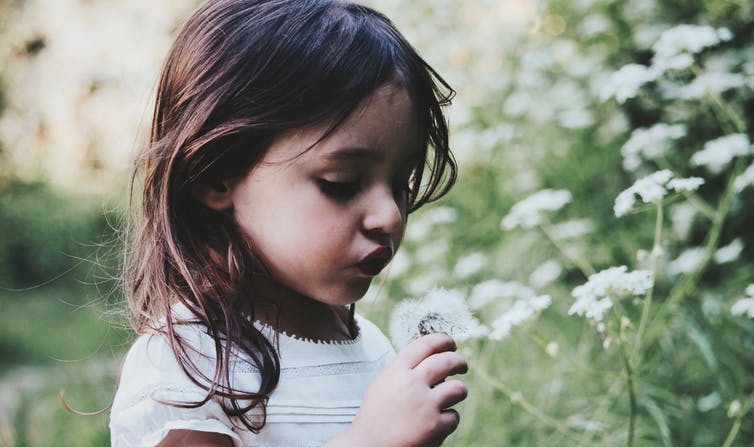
[248,278,357,341]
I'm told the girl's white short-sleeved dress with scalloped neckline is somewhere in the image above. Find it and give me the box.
[110,308,395,447]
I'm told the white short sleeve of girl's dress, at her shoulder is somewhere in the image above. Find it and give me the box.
[110,328,241,447]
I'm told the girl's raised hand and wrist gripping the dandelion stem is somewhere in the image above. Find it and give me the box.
[334,334,468,447]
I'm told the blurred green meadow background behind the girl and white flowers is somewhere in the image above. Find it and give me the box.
[0,0,754,446]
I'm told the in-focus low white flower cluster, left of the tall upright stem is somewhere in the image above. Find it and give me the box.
[568,265,654,322]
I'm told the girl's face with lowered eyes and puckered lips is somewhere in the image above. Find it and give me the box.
[228,84,420,305]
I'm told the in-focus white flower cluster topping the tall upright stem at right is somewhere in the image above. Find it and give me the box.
[613,169,704,217]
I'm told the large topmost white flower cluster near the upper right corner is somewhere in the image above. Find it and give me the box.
[652,24,733,72]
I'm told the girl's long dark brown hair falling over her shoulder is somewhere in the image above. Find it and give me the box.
[124,0,456,432]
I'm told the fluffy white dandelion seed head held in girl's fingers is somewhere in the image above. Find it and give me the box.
[390,289,484,349]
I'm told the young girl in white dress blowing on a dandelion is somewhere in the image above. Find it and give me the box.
[110,0,467,447]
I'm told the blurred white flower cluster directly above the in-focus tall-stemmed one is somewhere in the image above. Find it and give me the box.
[621,123,686,171]
